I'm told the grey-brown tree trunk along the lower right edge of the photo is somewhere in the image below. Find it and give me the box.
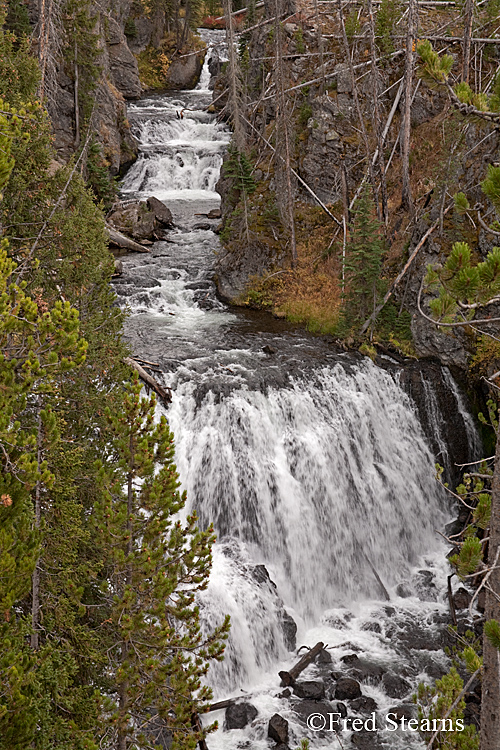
[480,430,500,750]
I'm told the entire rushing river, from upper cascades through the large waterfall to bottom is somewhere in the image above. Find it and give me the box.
[115,35,477,750]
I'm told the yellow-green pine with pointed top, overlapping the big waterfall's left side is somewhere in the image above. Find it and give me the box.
[96,379,229,750]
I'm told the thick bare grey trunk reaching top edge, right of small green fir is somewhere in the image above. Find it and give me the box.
[401,0,418,214]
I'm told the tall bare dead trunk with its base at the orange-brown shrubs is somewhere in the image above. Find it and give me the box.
[274,0,297,268]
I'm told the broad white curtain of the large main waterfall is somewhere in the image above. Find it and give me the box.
[170,360,444,619]
